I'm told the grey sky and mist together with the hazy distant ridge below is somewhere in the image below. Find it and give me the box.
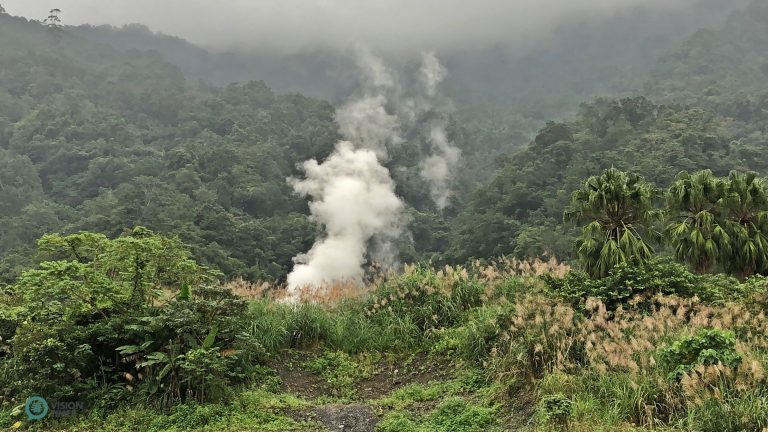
[1,0,747,108]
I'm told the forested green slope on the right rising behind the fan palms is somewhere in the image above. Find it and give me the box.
[448,2,768,261]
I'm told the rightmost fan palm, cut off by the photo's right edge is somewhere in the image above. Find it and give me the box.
[721,171,768,277]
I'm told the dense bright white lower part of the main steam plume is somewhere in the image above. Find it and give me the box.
[288,141,403,296]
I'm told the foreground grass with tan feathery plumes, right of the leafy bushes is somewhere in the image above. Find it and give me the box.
[6,262,768,432]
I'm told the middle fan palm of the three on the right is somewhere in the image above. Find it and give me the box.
[666,170,731,274]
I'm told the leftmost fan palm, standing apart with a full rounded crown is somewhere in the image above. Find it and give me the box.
[564,168,660,277]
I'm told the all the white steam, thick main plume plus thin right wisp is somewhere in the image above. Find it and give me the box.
[288,50,460,298]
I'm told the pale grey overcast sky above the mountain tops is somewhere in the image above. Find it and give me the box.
[0,0,704,49]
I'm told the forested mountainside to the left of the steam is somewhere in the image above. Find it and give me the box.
[0,15,337,278]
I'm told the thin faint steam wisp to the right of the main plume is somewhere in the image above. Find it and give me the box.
[419,52,461,210]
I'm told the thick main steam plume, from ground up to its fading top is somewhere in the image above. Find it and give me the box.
[288,50,404,299]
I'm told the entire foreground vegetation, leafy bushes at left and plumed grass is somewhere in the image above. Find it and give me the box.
[0,233,768,432]
